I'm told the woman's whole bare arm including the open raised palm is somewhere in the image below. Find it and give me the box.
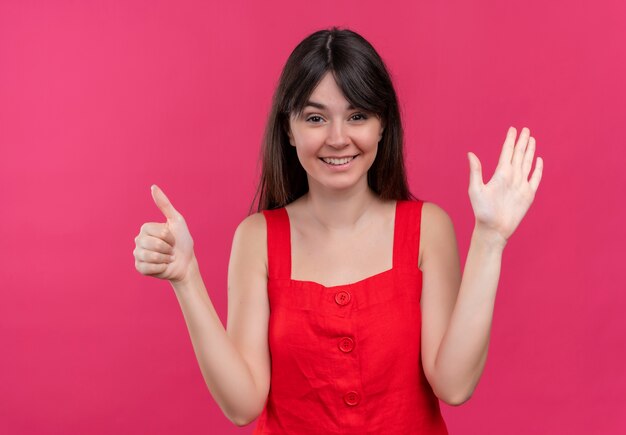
[421,128,543,405]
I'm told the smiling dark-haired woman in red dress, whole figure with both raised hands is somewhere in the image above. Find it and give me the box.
[134,28,543,434]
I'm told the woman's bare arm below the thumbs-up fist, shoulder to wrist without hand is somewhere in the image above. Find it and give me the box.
[172,214,270,426]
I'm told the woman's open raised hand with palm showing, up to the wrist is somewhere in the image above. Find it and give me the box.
[468,127,543,247]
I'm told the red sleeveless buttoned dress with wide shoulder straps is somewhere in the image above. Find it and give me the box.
[253,201,448,435]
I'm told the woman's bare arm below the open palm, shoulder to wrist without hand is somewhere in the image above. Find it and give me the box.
[422,204,503,405]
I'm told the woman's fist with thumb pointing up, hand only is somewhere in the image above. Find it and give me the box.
[133,185,194,283]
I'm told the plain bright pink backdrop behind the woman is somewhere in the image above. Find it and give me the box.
[0,0,626,434]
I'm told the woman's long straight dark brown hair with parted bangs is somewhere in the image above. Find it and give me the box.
[251,27,416,211]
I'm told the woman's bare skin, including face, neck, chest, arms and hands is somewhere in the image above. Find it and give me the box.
[134,70,543,425]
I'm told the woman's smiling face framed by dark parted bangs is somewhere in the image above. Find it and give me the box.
[288,72,384,195]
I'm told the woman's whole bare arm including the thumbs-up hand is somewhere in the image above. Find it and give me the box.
[133,185,270,426]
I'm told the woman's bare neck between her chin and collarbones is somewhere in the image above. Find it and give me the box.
[306,184,378,231]
